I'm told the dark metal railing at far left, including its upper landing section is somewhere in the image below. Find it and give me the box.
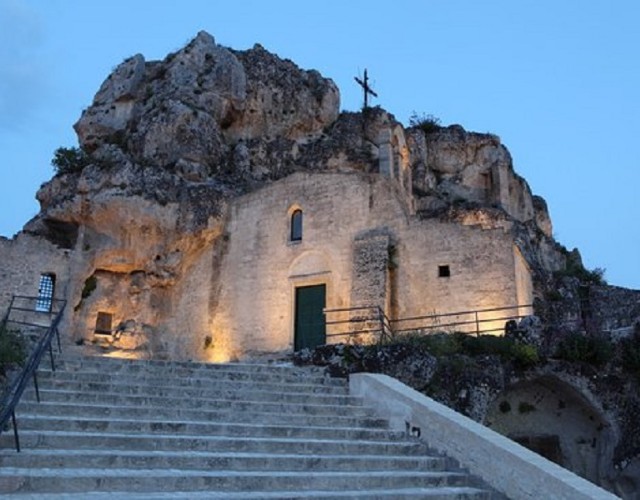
[0,295,66,452]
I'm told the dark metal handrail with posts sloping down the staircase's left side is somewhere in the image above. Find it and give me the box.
[0,297,67,452]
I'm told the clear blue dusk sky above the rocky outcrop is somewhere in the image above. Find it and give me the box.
[0,0,640,289]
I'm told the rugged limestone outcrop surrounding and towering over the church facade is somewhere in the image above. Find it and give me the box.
[0,32,640,498]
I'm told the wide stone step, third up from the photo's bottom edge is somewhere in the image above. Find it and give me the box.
[0,449,449,472]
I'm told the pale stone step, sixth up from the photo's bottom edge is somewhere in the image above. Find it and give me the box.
[16,400,388,429]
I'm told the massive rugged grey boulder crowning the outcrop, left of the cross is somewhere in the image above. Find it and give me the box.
[75,32,340,176]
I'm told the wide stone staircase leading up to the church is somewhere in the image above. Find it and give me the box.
[0,356,501,500]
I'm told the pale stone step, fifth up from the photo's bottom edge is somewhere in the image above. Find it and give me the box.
[7,415,404,441]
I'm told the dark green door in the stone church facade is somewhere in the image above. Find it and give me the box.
[294,285,327,351]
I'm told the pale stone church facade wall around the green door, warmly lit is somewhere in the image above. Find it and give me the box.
[211,172,518,357]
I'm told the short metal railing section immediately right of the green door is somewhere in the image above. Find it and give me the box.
[324,306,393,343]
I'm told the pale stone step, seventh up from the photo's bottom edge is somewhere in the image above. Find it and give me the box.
[22,389,372,416]
